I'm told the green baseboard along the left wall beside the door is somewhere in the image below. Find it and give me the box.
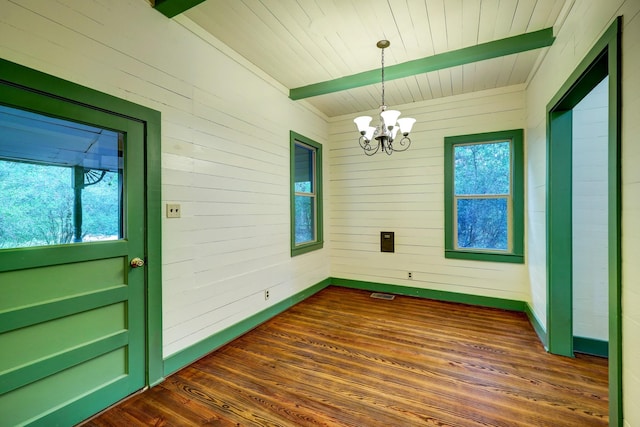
[164,278,331,377]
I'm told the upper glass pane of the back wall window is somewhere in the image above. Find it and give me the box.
[454,142,511,195]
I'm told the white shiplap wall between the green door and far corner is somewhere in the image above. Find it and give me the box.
[0,0,329,357]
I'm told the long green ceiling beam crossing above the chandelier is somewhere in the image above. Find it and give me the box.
[289,27,555,100]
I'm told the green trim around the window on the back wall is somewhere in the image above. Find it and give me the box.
[444,129,524,264]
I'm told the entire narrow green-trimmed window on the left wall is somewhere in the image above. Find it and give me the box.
[291,132,322,255]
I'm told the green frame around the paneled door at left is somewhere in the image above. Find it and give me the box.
[0,59,164,386]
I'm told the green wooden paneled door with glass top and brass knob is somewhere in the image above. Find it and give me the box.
[0,83,146,426]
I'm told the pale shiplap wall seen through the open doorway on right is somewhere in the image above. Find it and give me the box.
[571,78,609,341]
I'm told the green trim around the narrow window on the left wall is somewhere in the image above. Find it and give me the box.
[289,131,324,257]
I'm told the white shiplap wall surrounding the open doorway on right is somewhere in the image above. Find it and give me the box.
[527,0,640,427]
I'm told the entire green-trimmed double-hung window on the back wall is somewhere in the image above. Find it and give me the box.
[445,129,524,263]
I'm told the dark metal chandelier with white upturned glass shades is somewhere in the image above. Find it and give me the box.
[353,40,416,156]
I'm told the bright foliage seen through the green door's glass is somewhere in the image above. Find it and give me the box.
[0,160,120,248]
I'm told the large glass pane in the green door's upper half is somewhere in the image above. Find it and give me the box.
[0,106,123,248]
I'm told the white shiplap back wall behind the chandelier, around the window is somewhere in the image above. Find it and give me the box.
[327,86,529,301]
